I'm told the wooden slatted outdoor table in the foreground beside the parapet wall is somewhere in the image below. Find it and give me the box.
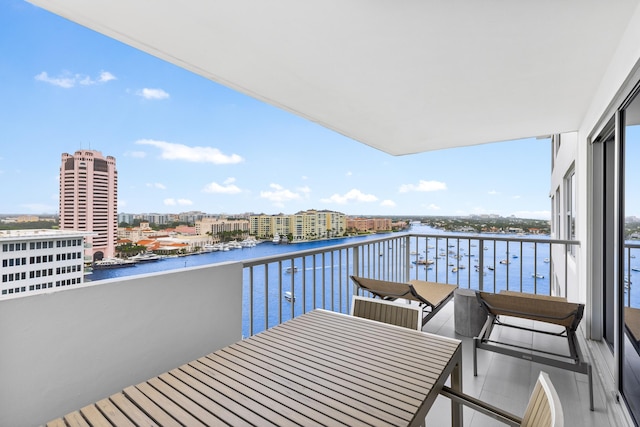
[47,310,462,427]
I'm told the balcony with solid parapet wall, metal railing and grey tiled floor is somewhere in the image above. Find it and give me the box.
[0,234,633,426]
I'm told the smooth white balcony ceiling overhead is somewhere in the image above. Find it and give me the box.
[30,0,639,155]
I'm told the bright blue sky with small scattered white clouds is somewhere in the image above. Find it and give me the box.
[0,0,550,219]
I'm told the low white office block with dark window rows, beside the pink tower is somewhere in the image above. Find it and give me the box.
[0,230,86,298]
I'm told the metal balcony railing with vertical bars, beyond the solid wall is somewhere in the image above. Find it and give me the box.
[243,233,580,337]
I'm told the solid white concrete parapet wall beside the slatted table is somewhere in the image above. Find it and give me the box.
[0,263,242,427]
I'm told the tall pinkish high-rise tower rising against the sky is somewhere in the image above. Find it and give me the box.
[60,150,118,261]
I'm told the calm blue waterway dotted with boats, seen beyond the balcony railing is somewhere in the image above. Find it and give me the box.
[86,226,640,336]
